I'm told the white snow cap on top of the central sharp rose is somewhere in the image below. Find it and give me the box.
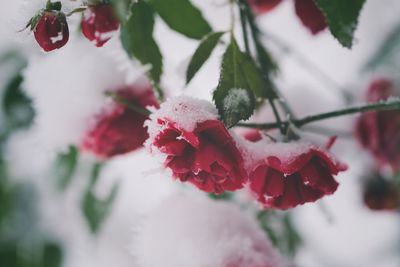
[145,95,218,140]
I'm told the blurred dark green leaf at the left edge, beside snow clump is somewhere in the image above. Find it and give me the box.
[3,73,34,130]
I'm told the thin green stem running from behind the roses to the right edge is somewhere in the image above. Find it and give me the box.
[237,100,400,129]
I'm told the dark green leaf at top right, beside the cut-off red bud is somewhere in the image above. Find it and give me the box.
[314,0,365,48]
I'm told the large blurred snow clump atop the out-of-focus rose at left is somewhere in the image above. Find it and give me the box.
[24,40,133,153]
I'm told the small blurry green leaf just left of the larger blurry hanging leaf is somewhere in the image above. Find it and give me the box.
[54,146,79,191]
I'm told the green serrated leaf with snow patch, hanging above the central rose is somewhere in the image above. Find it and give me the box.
[213,37,273,127]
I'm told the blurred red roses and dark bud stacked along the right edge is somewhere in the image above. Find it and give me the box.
[355,78,400,210]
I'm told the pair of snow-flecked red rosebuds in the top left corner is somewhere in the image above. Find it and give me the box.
[28,2,119,52]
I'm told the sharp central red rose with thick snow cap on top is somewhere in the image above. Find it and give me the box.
[146,96,247,193]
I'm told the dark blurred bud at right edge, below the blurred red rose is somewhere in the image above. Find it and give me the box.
[363,174,400,211]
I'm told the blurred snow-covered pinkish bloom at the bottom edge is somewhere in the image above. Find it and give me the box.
[132,196,286,267]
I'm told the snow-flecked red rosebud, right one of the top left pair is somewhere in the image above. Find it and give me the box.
[81,5,119,47]
